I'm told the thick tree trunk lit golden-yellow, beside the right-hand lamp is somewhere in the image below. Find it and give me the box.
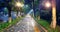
[51,0,56,29]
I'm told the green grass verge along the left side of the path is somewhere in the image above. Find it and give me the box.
[0,17,23,32]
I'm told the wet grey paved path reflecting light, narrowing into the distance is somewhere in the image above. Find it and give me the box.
[4,15,44,32]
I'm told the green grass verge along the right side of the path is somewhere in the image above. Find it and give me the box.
[35,19,58,32]
